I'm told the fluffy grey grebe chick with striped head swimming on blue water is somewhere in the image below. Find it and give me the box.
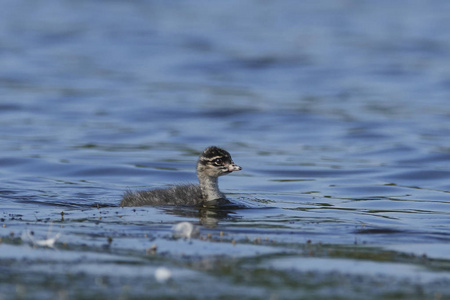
[120,146,242,206]
